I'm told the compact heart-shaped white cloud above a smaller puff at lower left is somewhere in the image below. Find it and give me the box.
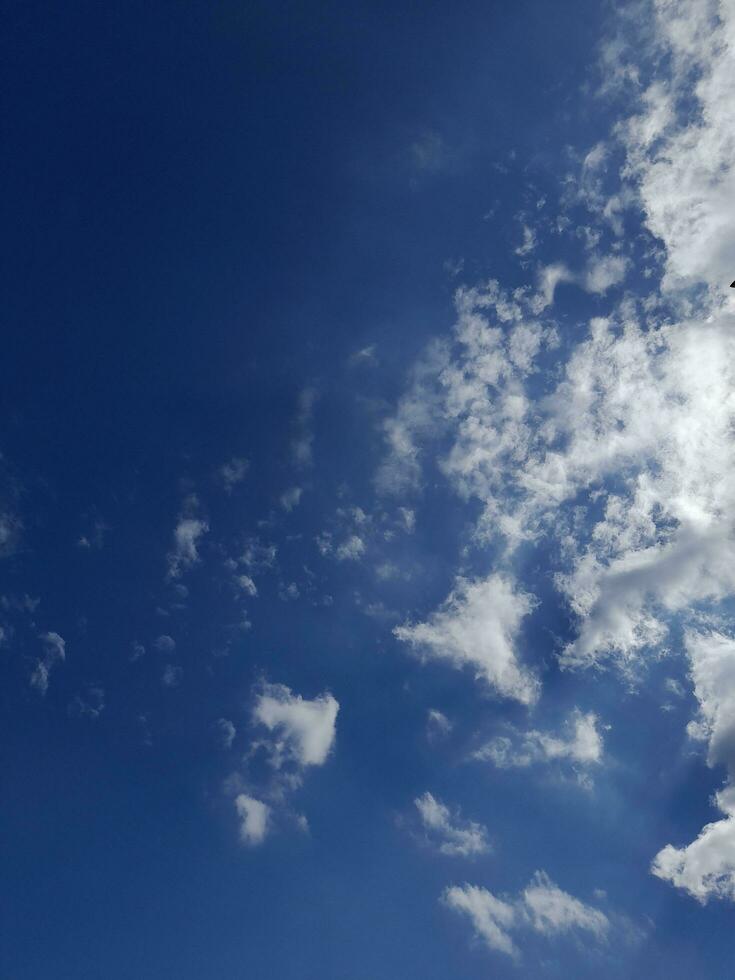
[252,684,339,768]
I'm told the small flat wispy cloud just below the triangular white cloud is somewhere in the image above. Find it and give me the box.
[473,708,603,769]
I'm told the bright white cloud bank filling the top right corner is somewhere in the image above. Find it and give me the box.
[619,0,735,292]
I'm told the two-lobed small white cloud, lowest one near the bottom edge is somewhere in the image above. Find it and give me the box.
[442,871,610,957]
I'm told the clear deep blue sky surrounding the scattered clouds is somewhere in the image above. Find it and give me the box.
[0,0,732,980]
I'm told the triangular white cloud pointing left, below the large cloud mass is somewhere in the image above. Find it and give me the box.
[393,574,539,704]
